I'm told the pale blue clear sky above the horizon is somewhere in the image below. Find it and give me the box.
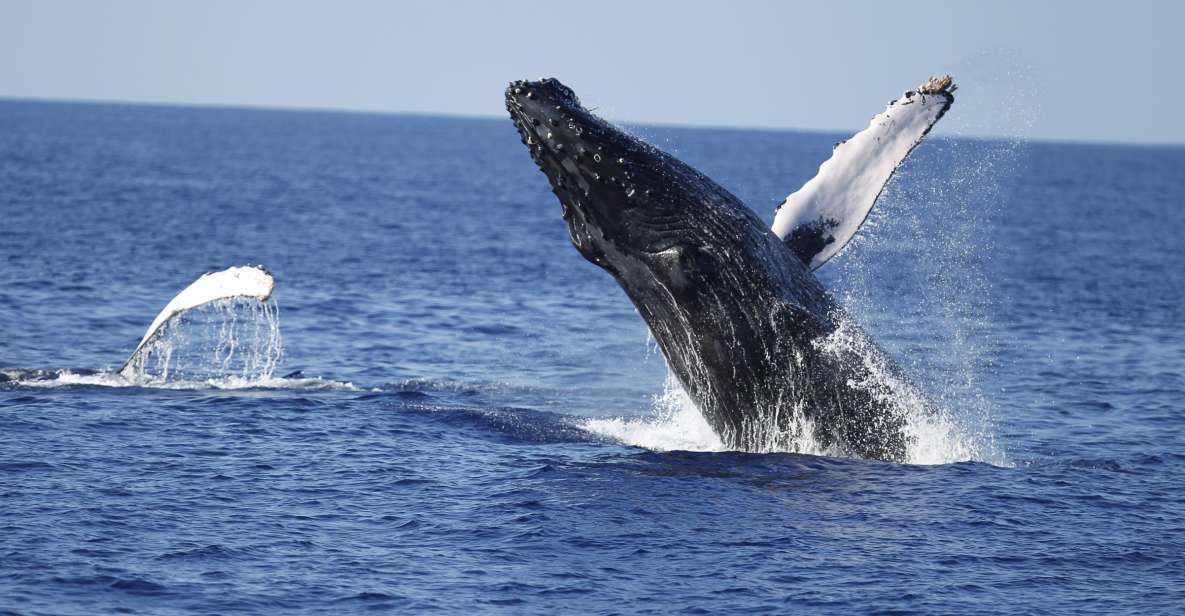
[0,0,1185,143]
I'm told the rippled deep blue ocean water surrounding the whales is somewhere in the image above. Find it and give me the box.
[0,101,1185,614]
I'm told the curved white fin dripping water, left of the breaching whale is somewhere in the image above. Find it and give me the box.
[120,265,276,374]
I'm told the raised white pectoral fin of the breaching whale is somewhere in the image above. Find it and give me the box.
[774,75,955,269]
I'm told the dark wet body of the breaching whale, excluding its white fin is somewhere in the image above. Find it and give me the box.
[506,79,907,461]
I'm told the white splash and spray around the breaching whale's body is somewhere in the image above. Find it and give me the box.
[584,129,1025,466]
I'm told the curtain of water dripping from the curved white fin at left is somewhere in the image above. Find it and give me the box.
[122,297,283,384]
